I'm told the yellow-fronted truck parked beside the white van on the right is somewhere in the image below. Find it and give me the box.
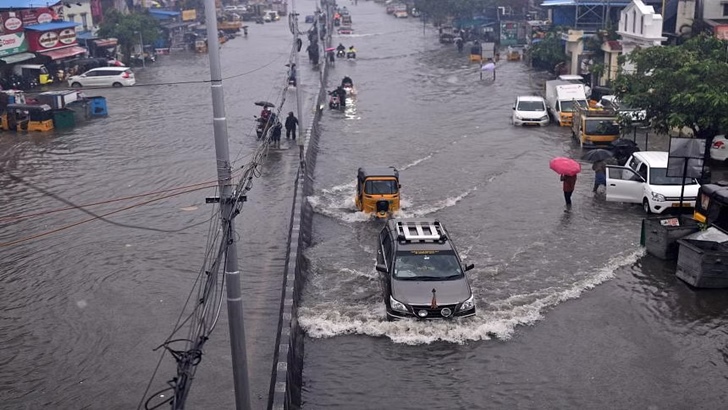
[571,104,620,148]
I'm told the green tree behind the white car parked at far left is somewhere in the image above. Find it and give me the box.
[99,9,160,65]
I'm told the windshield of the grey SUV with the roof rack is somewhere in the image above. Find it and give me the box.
[393,251,464,280]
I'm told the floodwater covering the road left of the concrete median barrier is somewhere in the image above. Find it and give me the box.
[0,2,318,409]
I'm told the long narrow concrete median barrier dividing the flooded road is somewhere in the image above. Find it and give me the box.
[268,2,332,410]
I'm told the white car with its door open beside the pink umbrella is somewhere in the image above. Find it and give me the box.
[607,151,700,214]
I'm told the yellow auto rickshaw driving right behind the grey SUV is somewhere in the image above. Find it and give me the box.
[354,167,401,218]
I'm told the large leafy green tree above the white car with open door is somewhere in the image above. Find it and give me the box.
[614,35,728,162]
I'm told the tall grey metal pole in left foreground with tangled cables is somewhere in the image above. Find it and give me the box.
[204,0,250,410]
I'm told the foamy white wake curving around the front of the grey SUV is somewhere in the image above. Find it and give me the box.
[298,249,644,345]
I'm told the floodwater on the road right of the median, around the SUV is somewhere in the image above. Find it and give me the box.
[299,2,728,409]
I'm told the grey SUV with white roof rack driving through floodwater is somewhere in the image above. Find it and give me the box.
[377,219,475,320]
